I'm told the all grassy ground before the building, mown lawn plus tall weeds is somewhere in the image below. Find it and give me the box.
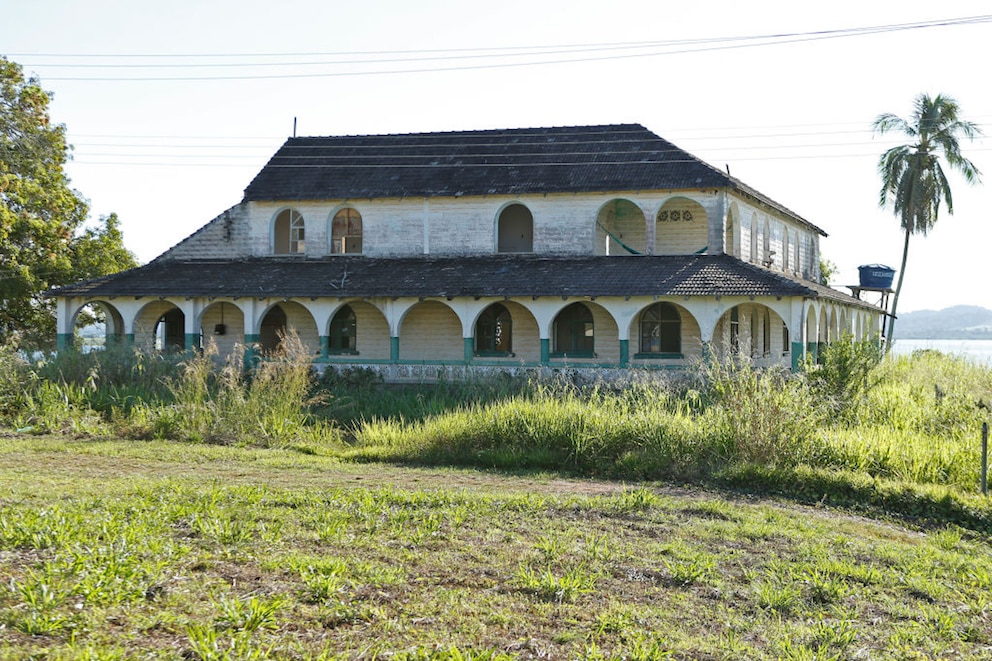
[0,338,992,659]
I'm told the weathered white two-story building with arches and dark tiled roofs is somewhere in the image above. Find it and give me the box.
[53,125,883,381]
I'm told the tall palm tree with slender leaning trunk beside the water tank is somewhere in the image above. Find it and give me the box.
[872,94,982,347]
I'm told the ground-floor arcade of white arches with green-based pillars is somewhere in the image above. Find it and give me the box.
[60,297,879,368]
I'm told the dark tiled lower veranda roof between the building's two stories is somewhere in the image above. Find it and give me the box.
[49,255,861,304]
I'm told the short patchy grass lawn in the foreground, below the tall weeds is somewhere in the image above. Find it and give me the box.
[0,436,992,659]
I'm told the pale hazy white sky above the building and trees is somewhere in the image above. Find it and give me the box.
[0,0,992,312]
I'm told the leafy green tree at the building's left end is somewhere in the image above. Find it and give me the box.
[0,57,136,346]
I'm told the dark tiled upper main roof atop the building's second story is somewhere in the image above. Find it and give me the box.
[244,124,826,236]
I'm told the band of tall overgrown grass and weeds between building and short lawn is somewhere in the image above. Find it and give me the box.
[0,337,992,506]
